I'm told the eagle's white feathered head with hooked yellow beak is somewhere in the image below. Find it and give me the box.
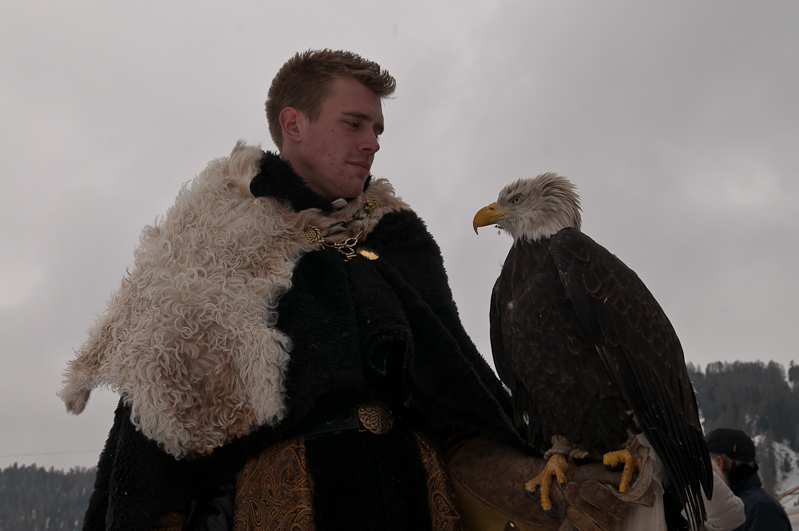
[473,173,582,241]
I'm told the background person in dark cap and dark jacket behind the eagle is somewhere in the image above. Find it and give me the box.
[707,428,791,531]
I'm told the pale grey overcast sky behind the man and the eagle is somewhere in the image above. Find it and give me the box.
[0,0,799,468]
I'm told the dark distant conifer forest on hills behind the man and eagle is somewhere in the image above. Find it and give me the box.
[0,361,799,531]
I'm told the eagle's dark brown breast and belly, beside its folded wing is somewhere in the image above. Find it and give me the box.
[491,234,635,459]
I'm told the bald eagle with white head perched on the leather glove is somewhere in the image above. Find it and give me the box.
[473,173,713,528]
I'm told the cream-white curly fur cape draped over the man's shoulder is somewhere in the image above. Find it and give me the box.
[58,142,408,458]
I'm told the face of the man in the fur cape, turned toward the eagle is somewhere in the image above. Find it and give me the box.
[287,77,383,201]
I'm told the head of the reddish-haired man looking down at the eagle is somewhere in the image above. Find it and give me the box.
[266,50,396,200]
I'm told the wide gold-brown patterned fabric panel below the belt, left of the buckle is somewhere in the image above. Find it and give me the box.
[233,438,316,531]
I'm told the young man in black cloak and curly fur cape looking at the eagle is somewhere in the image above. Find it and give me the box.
[61,50,648,531]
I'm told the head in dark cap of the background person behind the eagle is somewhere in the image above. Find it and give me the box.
[705,428,758,484]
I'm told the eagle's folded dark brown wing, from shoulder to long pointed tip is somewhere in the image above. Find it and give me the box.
[550,229,713,523]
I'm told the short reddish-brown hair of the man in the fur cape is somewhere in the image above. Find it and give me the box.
[266,49,397,149]
